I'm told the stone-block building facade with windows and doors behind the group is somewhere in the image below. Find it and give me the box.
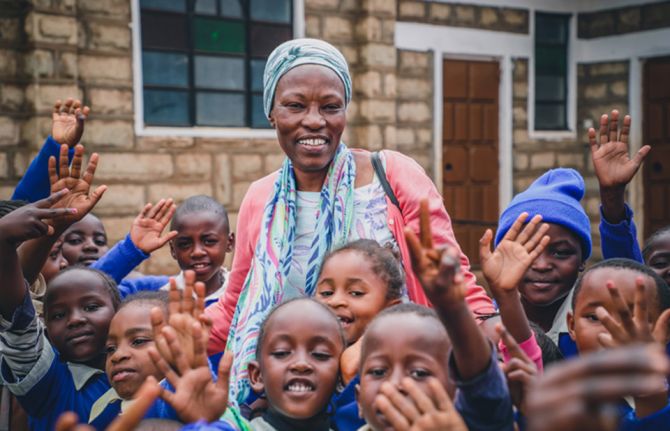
[0,0,670,273]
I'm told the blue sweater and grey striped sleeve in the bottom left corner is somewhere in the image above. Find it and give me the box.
[0,289,120,431]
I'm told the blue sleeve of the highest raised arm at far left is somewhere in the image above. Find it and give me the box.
[12,136,74,202]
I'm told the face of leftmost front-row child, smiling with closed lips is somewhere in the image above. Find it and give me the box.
[44,269,116,366]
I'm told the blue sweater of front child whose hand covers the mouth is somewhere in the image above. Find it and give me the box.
[333,346,514,431]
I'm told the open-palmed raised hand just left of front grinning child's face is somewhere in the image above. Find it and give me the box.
[149,322,233,423]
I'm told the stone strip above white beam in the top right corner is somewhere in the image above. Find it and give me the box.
[577,1,670,39]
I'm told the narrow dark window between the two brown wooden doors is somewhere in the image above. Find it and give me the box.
[535,13,570,130]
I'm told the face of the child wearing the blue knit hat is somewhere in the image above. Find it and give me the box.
[519,223,582,305]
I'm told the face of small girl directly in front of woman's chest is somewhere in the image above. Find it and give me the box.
[316,250,400,344]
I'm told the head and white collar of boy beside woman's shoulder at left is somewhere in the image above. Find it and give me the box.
[163,195,235,305]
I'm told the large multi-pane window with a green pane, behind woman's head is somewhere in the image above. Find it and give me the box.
[140,0,293,128]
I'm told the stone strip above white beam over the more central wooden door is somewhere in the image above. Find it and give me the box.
[398,0,528,34]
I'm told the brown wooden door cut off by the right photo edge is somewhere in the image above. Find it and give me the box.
[643,57,670,237]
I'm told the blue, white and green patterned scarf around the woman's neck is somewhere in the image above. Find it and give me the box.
[226,143,356,405]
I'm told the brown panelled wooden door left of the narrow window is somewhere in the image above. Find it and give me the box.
[442,60,500,265]
